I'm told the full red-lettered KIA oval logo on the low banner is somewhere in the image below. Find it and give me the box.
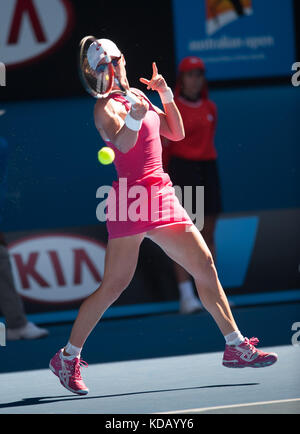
[9,234,105,304]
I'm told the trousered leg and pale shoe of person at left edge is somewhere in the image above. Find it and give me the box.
[0,236,48,341]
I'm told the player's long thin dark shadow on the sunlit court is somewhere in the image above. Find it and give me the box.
[0,383,259,410]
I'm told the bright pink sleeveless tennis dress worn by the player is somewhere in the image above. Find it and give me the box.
[106,89,193,239]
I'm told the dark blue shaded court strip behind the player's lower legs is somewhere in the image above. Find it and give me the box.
[0,303,300,373]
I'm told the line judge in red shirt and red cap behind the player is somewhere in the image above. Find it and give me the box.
[163,57,221,313]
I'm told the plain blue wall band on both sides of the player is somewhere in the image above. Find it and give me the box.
[0,86,300,231]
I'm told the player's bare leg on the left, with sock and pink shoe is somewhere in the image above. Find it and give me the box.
[49,235,144,395]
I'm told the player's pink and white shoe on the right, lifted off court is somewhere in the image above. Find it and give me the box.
[223,338,278,368]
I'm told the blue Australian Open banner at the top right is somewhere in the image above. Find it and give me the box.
[173,0,295,80]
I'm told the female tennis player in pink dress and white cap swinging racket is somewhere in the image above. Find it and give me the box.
[49,40,277,395]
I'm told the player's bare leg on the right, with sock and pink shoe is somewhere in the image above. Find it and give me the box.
[147,225,278,368]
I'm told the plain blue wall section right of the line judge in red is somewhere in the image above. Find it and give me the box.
[211,86,300,212]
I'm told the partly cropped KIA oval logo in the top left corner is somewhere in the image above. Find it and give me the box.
[0,0,73,68]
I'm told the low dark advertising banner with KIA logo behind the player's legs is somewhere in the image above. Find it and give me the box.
[2,209,300,320]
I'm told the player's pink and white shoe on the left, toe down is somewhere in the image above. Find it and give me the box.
[49,348,89,395]
